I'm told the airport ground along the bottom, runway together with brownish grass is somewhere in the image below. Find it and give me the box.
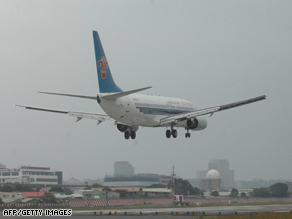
[0,204,292,219]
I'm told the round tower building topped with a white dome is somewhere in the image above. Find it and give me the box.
[202,170,221,191]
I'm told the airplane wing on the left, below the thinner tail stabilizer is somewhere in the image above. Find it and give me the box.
[15,105,110,125]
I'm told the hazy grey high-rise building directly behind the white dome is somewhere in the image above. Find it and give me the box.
[209,159,235,188]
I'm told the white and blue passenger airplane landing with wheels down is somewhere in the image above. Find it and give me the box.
[16,31,267,139]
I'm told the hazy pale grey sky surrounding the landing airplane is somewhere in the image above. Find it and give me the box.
[0,0,292,180]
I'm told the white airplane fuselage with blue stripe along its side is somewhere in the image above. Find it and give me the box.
[98,93,196,127]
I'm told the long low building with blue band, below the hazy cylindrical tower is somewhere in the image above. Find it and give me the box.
[104,173,171,187]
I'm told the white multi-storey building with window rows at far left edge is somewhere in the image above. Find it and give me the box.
[0,165,63,185]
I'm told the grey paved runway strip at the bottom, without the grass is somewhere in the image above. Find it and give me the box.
[0,204,292,219]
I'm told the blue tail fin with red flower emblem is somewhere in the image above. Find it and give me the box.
[92,31,122,93]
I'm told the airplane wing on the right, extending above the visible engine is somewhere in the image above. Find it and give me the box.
[160,95,267,125]
